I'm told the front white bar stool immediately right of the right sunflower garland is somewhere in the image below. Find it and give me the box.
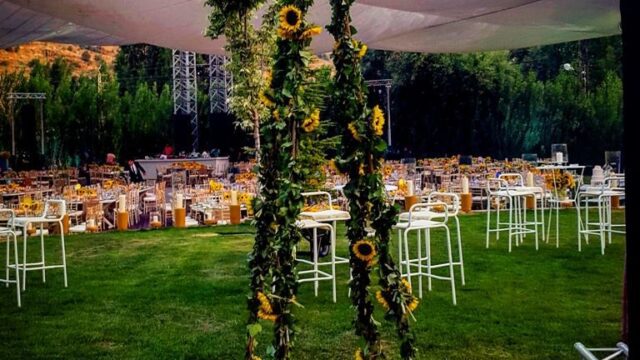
[394,201,457,305]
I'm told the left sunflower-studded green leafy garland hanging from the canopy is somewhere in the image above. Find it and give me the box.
[252,0,320,359]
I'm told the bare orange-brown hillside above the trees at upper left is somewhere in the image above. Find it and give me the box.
[0,41,119,75]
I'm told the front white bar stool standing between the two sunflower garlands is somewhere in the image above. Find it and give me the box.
[294,220,336,303]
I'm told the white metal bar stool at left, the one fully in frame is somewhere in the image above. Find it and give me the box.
[12,200,67,290]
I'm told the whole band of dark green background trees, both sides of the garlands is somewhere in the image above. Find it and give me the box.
[0,36,623,166]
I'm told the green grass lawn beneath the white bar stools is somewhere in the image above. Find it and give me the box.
[0,210,624,359]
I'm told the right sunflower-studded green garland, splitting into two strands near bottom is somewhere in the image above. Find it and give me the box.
[327,0,418,359]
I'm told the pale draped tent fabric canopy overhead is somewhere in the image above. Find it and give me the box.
[0,0,620,54]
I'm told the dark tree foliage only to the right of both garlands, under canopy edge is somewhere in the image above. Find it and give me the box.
[365,36,622,164]
